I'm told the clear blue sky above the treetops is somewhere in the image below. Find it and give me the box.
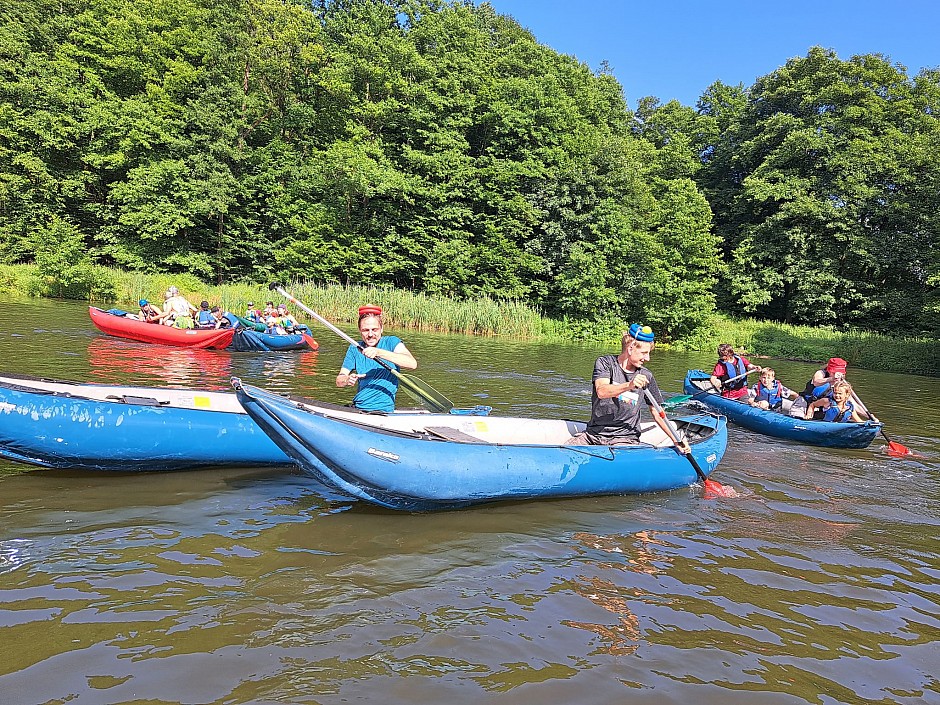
[481,0,940,107]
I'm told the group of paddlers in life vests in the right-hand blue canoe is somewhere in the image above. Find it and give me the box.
[711,343,865,423]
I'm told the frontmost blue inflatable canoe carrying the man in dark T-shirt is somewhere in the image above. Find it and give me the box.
[233,380,728,511]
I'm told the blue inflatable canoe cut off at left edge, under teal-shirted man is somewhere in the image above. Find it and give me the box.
[0,375,489,472]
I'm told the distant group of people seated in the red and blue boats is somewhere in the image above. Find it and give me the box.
[137,286,299,335]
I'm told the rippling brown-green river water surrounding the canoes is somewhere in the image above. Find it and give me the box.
[0,301,940,705]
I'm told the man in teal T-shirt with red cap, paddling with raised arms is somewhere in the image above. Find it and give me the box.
[336,305,418,411]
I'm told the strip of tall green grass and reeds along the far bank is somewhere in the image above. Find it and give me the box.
[0,265,940,376]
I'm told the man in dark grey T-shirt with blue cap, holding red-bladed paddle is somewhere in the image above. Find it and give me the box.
[565,323,689,453]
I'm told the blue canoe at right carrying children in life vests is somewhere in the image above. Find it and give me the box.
[683,370,881,448]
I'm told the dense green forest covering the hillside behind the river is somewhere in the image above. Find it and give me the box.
[0,0,940,338]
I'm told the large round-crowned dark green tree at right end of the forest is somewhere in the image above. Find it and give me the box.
[706,48,938,329]
